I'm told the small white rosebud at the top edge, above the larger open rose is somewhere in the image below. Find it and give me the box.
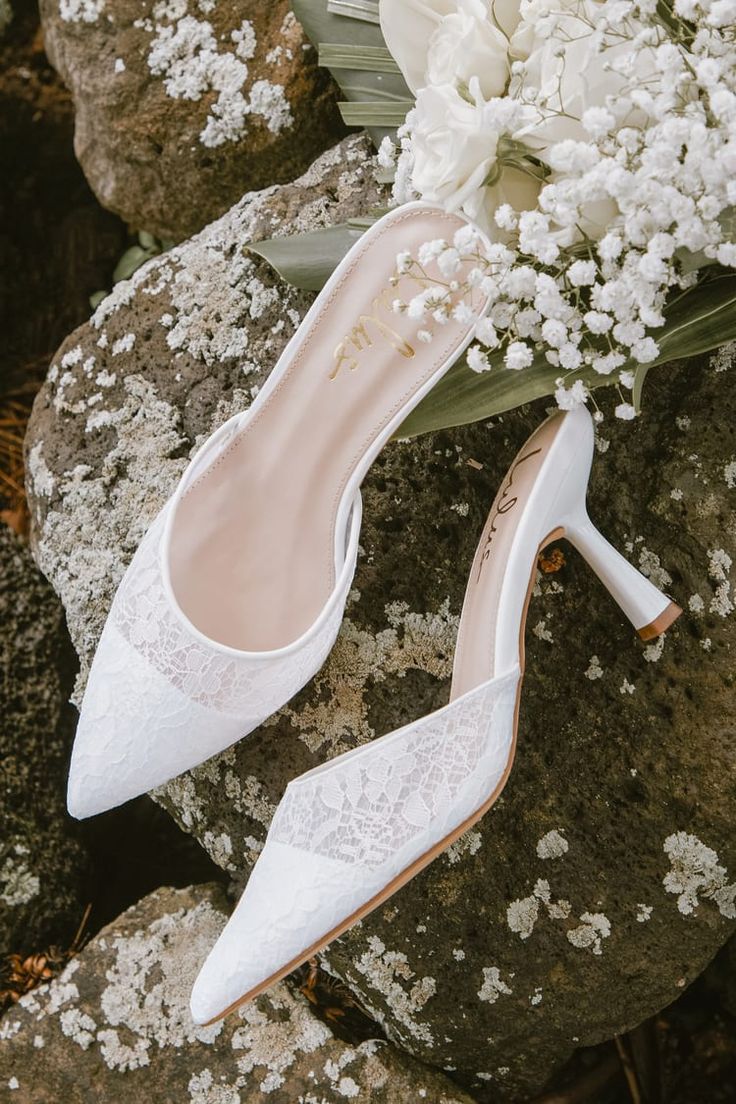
[426,0,510,98]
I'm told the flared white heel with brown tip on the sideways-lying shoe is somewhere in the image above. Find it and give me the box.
[565,513,682,640]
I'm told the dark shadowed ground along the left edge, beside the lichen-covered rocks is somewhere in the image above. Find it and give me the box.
[0,0,126,531]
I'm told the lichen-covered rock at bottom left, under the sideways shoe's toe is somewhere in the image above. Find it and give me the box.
[0,885,471,1104]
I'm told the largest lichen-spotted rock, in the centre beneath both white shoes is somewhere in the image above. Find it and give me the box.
[23,133,736,1100]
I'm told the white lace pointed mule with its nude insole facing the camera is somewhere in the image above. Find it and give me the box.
[67,203,492,818]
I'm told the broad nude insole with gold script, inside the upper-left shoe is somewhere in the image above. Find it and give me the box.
[169,209,485,651]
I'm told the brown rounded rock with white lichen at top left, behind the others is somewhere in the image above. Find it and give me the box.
[41,0,344,241]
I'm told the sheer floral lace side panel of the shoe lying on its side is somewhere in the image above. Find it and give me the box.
[268,670,520,869]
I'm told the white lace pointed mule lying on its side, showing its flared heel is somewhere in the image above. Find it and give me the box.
[191,408,681,1023]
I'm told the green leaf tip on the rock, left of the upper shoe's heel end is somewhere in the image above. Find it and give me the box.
[247,225,362,291]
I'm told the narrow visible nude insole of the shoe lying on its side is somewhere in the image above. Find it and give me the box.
[450,414,563,701]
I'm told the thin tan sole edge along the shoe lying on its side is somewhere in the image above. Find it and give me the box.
[203,528,565,1027]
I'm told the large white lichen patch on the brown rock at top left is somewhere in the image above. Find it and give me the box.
[146,0,294,148]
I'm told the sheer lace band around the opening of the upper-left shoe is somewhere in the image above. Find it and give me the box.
[110,509,353,718]
